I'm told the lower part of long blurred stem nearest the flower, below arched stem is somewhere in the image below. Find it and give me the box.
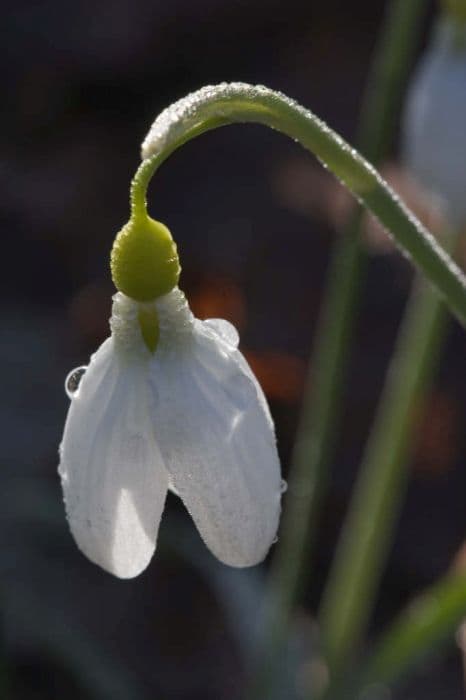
[250,213,364,698]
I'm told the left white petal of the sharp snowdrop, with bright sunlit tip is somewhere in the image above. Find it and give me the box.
[59,339,168,578]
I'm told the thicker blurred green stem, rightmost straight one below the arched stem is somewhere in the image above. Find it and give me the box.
[320,228,460,686]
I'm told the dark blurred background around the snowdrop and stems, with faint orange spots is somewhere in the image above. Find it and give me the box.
[0,0,466,700]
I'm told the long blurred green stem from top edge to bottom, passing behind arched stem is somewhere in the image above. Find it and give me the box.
[246,0,425,698]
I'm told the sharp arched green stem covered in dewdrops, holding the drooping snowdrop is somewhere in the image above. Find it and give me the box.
[132,83,466,324]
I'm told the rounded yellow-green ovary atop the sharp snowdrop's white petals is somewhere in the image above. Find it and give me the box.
[110,214,181,302]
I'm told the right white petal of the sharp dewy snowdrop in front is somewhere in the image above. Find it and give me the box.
[151,321,281,566]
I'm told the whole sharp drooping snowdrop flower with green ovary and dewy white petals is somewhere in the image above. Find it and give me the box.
[59,217,282,578]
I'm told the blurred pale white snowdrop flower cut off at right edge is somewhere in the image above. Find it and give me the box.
[403,10,466,228]
